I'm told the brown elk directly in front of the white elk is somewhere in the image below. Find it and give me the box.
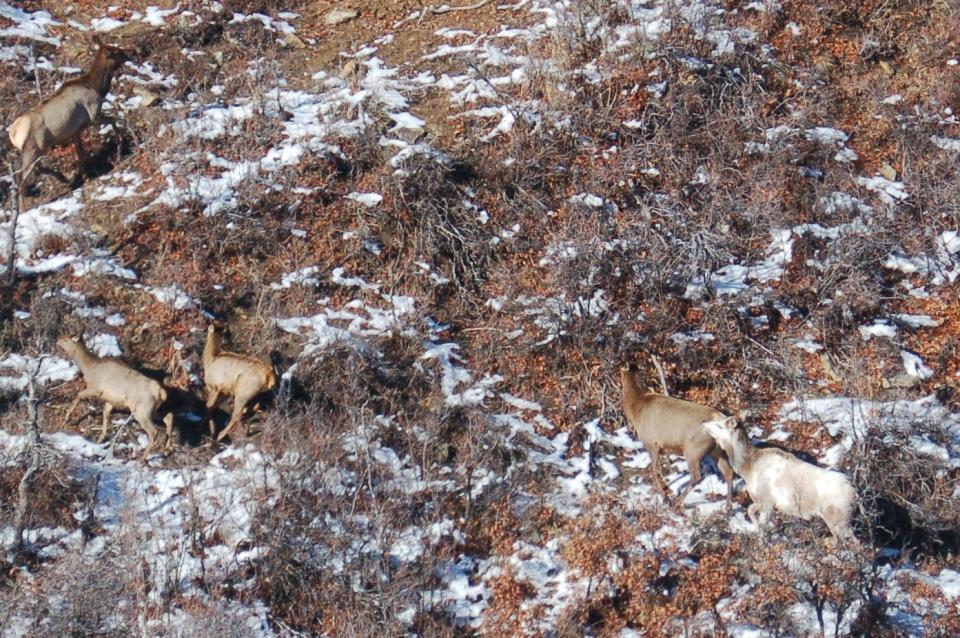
[620,363,733,510]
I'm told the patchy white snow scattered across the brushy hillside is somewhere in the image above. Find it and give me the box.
[0,0,960,636]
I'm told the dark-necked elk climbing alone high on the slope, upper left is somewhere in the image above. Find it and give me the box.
[7,36,133,190]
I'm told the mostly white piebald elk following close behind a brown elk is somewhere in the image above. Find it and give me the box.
[703,417,857,542]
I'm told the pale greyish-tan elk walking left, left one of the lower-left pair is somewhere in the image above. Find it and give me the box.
[57,337,173,459]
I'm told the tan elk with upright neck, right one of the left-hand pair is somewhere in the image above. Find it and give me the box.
[203,323,277,441]
